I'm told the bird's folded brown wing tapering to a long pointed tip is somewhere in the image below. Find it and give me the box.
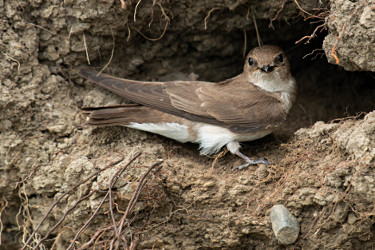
[80,66,286,132]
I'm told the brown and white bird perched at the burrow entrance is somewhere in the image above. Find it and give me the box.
[79,45,297,171]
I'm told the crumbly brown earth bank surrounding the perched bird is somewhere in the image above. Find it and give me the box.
[0,0,375,249]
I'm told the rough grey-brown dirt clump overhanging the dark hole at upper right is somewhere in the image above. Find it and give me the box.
[323,0,375,71]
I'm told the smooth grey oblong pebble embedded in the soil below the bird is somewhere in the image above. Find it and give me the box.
[271,204,300,245]
